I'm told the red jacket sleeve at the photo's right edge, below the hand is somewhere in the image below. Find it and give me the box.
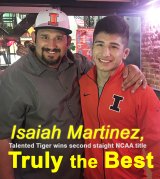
[137,87,160,179]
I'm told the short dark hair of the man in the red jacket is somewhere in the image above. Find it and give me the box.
[93,15,129,46]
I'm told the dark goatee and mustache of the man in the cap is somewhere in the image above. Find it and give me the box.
[42,47,62,66]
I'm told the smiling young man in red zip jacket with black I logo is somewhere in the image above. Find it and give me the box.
[80,16,160,179]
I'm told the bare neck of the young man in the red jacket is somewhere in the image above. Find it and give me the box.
[97,70,110,88]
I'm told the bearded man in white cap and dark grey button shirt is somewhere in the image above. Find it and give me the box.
[0,9,145,179]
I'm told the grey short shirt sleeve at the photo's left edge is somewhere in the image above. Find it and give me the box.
[0,70,25,139]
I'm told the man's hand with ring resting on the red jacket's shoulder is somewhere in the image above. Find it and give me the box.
[122,65,147,93]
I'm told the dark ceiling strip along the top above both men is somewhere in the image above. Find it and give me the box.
[0,0,159,16]
